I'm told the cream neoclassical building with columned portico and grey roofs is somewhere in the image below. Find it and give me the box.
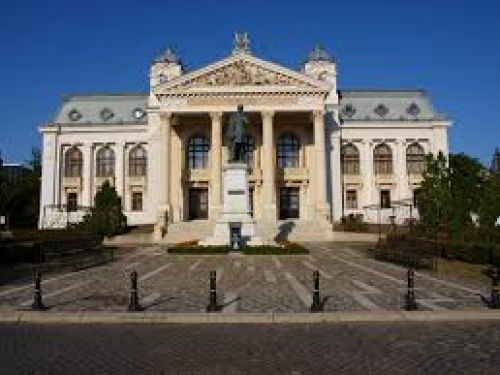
[40,38,450,239]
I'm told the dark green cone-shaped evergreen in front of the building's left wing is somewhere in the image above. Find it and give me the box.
[82,181,127,238]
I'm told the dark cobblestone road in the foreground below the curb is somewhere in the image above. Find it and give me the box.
[0,322,500,375]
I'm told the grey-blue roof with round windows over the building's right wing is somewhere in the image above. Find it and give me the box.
[340,89,446,121]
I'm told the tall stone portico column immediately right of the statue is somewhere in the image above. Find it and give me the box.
[261,111,276,221]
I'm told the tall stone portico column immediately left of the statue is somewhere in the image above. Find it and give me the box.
[209,112,222,220]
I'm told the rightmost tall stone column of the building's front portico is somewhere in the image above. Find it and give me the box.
[313,111,329,219]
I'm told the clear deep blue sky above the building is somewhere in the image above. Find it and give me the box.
[0,0,500,164]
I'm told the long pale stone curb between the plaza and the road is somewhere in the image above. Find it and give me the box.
[0,310,500,324]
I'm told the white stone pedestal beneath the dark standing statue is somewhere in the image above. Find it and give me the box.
[200,163,264,246]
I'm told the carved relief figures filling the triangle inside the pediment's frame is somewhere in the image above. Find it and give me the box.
[175,60,313,88]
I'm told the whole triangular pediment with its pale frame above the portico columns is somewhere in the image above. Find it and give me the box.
[153,53,331,95]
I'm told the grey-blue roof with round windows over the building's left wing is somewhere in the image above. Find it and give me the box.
[53,93,148,124]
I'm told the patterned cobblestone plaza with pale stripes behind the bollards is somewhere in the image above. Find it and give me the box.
[0,243,489,312]
